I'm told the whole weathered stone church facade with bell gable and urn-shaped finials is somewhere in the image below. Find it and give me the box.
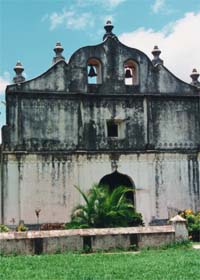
[0,21,200,225]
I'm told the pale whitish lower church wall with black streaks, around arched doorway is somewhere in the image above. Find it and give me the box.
[3,152,200,224]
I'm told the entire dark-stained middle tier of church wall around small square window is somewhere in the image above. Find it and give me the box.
[4,93,200,151]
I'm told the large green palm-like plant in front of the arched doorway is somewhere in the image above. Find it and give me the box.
[66,185,143,228]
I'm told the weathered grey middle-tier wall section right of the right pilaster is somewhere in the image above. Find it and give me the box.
[149,97,200,150]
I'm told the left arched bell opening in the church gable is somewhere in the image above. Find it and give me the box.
[87,58,102,84]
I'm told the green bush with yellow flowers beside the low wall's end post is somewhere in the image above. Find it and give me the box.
[181,209,200,241]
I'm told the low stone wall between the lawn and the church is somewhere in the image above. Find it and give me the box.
[0,225,175,255]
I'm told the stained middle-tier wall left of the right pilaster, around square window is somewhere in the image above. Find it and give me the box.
[4,96,147,151]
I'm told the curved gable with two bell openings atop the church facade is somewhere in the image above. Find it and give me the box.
[7,26,199,95]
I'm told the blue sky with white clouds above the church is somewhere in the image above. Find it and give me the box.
[0,0,200,140]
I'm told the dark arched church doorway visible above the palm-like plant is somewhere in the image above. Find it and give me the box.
[99,171,135,204]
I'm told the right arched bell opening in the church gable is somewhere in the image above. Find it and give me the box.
[124,59,139,85]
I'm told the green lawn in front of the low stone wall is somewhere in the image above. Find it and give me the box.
[0,248,200,280]
